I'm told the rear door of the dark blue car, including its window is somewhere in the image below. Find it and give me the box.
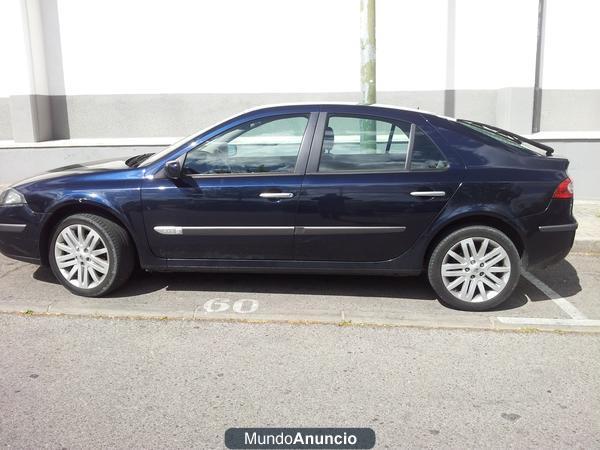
[295,107,463,261]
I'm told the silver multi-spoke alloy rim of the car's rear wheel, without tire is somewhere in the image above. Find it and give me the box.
[441,237,511,303]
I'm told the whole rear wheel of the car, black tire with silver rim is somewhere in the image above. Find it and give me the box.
[427,226,521,311]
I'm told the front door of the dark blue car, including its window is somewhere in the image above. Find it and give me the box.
[142,114,316,260]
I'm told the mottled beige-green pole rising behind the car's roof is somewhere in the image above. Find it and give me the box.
[360,0,377,105]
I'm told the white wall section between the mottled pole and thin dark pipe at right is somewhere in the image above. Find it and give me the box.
[377,0,538,91]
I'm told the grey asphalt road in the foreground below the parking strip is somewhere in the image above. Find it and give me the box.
[0,315,600,448]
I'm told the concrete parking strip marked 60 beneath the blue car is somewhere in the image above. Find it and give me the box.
[0,255,600,332]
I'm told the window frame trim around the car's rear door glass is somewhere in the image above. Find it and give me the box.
[306,111,451,175]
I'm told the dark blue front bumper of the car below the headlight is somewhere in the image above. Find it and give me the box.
[0,205,45,264]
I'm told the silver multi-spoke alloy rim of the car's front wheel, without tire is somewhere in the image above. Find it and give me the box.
[54,224,110,289]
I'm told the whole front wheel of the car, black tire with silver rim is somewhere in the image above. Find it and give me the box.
[48,214,135,297]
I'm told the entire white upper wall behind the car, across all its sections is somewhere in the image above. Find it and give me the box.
[0,0,600,97]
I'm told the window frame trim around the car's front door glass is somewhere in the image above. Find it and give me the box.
[181,111,319,179]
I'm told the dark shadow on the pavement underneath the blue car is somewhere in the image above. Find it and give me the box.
[33,267,527,311]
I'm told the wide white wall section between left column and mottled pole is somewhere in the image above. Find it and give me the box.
[59,0,360,94]
